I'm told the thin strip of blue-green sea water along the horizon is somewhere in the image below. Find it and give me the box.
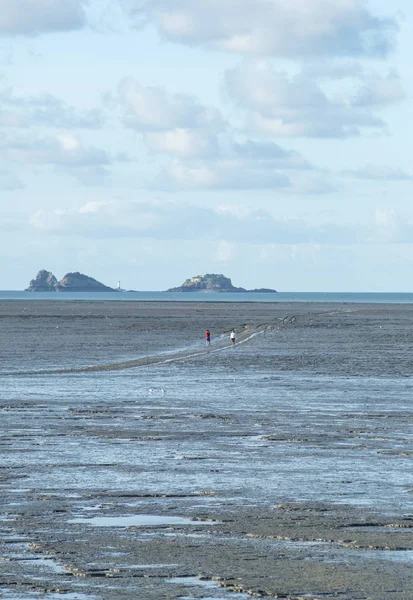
[0,290,413,304]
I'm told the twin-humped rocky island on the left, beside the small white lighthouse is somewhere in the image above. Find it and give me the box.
[25,269,117,292]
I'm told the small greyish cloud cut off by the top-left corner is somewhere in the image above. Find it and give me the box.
[0,0,89,36]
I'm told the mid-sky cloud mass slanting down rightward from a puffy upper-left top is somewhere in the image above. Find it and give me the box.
[109,78,322,190]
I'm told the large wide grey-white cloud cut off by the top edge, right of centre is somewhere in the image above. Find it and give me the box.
[121,0,398,58]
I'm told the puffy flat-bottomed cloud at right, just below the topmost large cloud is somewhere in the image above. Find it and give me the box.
[225,61,403,138]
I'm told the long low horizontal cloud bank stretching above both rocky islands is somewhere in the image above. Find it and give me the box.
[30,201,364,245]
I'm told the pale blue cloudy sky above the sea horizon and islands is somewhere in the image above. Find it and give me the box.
[0,0,413,292]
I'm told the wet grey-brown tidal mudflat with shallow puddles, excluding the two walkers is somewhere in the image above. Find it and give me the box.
[0,299,413,600]
